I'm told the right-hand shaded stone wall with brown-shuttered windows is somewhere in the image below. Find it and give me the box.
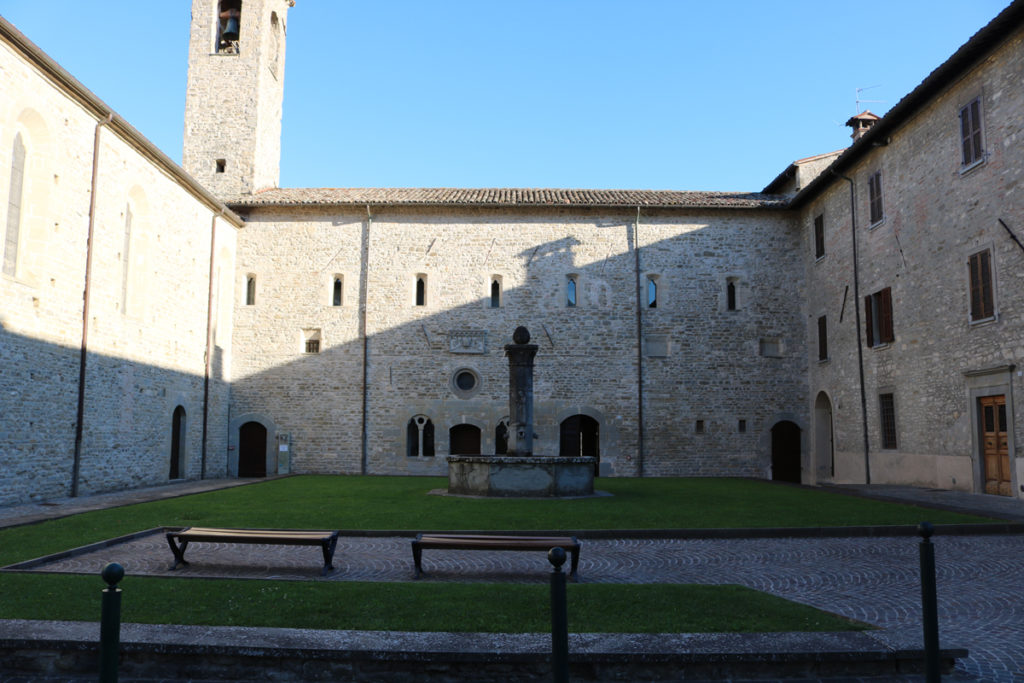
[801,26,1024,496]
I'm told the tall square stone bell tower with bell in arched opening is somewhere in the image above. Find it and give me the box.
[181,0,295,199]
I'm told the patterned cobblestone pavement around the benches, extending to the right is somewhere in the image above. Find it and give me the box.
[12,533,1024,683]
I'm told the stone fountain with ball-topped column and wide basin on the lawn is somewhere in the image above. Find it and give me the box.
[447,327,597,498]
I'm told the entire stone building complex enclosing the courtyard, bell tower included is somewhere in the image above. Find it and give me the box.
[0,0,1024,505]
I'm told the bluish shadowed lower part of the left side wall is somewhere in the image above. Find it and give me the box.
[0,317,228,505]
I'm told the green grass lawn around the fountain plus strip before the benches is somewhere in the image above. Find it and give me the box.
[0,476,991,633]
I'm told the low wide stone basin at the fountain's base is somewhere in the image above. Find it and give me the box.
[447,456,597,498]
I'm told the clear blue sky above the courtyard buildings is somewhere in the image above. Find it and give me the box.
[0,0,1009,190]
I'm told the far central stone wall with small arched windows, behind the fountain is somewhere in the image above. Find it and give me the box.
[232,207,806,475]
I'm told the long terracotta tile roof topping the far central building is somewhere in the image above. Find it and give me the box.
[232,187,786,209]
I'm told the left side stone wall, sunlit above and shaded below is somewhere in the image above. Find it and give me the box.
[0,28,237,504]
